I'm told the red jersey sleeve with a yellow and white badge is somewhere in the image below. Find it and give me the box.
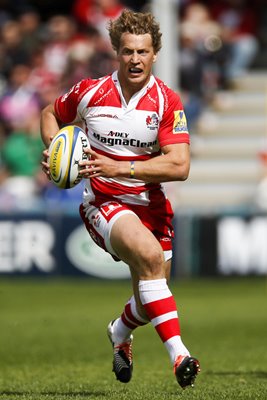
[158,89,190,147]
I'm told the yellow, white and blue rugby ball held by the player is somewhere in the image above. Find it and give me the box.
[48,125,90,189]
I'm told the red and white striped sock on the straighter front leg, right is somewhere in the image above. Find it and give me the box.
[139,279,189,364]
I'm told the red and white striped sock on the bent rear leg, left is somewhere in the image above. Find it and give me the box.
[112,296,149,344]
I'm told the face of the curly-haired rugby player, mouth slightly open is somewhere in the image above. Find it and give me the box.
[117,33,157,91]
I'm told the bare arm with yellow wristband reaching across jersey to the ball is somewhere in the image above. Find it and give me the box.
[80,143,190,183]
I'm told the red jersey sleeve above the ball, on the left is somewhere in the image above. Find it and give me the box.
[54,79,91,124]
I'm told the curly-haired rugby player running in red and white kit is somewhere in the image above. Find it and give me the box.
[41,10,200,388]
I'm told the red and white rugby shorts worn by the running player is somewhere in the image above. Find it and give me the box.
[80,200,174,261]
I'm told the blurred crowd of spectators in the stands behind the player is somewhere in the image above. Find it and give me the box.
[0,0,267,209]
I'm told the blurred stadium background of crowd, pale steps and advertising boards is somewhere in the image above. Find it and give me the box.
[0,0,267,279]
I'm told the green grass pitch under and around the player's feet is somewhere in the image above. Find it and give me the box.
[0,278,267,400]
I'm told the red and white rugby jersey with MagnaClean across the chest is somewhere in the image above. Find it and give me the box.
[55,71,189,205]
